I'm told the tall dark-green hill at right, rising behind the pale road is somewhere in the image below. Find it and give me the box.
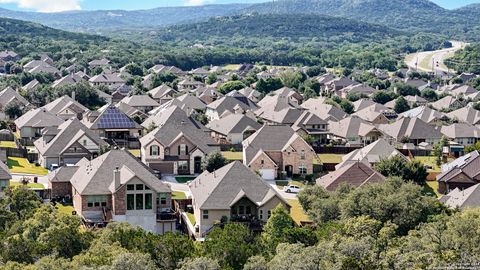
[243,0,480,40]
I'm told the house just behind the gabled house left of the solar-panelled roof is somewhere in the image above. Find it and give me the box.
[15,108,64,138]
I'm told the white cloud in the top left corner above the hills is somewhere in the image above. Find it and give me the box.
[0,0,81,12]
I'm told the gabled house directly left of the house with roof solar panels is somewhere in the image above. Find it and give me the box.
[34,118,107,168]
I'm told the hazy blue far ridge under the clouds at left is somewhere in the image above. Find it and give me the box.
[0,4,248,32]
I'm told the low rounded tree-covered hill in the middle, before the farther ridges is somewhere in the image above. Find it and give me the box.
[159,14,402,42]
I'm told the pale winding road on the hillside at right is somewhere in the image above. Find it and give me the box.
[405,41,468,72]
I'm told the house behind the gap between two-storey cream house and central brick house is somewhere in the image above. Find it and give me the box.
[207,114,262,144]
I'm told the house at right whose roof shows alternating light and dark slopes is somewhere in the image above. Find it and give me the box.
[379,117,443,146]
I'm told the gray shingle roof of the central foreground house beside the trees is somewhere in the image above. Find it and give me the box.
[189,161,288,210]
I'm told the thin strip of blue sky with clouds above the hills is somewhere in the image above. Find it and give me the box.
[0,0,480,12]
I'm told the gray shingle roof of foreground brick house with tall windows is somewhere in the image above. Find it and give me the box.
[70,150,171,195]
